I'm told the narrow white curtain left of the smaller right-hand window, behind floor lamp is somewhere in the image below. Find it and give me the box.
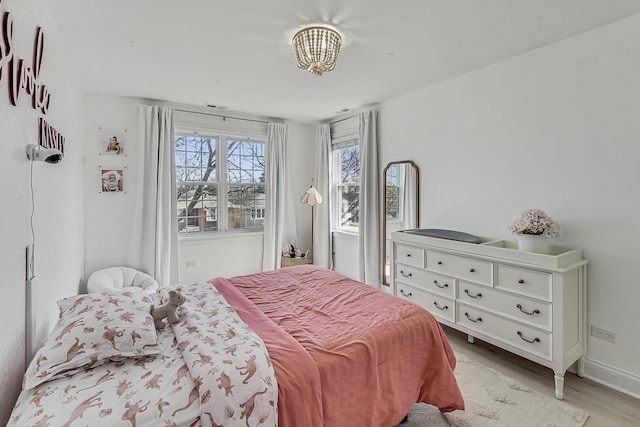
[312,124,333,268]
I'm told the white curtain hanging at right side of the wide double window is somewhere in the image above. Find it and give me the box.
[262,123,296,271]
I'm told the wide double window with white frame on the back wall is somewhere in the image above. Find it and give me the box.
[175,132,266,236]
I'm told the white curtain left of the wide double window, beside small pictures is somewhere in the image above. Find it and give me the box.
[128,105,178,286]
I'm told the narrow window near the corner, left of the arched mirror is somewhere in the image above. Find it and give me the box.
[332,140,360,232]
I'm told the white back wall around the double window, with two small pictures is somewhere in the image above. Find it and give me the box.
[84,94,315,283]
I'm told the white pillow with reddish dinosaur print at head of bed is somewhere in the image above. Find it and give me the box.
[22,291,162,390]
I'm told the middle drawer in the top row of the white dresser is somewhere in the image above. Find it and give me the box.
[427,251,493,286]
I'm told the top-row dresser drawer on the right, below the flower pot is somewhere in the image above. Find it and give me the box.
[496,264,551,301]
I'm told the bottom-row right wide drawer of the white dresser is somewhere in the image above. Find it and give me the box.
[456,303,552,360]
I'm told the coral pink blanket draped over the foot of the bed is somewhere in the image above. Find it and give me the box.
[212,265,464,427]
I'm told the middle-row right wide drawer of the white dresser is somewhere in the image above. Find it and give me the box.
[458,282,552,332]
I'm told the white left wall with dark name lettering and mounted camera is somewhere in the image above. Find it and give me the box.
[0,0,83,425]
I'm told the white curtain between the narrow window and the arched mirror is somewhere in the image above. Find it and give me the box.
[358,110,382,288]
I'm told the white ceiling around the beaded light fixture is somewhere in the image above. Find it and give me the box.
[48,0,640,122]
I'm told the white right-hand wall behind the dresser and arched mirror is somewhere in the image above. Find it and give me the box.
[379,16,640,395]
